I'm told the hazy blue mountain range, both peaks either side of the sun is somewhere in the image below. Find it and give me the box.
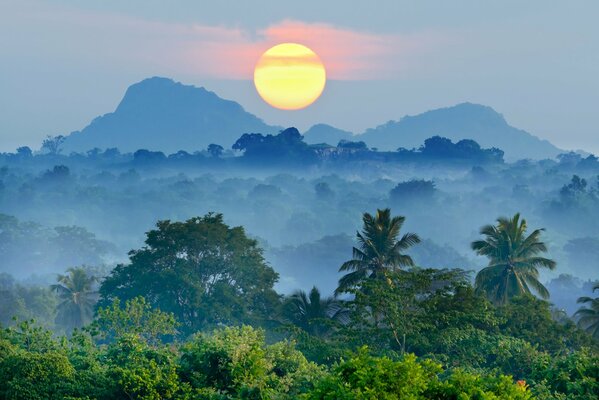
[64,77,563,160]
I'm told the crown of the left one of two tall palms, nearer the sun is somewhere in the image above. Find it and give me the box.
[335,208,420,294]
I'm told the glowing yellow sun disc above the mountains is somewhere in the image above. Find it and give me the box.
[254,43,327,110]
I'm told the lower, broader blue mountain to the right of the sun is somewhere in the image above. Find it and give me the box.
[354,103,563,160]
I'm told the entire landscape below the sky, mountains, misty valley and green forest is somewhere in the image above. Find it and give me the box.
[0,78,599,400]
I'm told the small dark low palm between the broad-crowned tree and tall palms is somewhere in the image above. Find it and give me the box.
[283,286,347,336]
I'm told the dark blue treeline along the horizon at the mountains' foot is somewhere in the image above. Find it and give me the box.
[3,128,504,167]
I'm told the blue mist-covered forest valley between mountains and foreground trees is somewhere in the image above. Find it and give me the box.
[0,126,599,309]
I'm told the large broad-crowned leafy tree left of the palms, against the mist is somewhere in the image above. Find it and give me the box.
[100,213,278,335]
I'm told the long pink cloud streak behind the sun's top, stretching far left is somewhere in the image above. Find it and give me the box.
[0,0,445,80]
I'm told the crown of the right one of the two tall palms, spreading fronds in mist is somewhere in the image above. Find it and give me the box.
[472,214,556,304]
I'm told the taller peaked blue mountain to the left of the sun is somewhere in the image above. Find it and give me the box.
[64,77,281,153]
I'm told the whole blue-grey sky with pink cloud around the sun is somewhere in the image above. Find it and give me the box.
[0,0,599,154]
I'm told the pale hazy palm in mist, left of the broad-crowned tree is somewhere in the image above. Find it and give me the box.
[51,267,97,332]
